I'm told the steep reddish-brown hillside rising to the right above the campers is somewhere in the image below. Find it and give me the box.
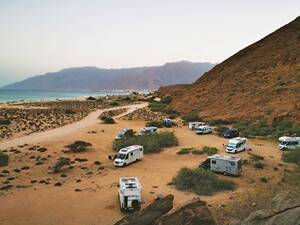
[158,17,300,121]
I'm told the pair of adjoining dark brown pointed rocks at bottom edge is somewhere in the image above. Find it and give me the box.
[115,195,216,225]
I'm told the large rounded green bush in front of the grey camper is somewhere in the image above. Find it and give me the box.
[172,168,235,195]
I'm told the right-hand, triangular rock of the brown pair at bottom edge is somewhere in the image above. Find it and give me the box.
[155,198,216,225]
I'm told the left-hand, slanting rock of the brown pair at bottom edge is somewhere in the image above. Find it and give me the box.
[115,195,174,225]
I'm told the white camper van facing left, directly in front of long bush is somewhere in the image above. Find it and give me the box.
[114,145,144,167]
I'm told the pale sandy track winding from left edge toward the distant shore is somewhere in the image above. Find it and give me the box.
[0,103,148,149]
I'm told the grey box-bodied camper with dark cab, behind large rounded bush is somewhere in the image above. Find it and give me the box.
[199,155,242,176]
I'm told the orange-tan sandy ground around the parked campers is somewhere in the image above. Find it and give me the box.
[0,105,283,225]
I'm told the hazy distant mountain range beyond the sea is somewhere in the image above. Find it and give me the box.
[2,61,214,91]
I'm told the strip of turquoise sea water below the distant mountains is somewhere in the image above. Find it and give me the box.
[0,90,131,102]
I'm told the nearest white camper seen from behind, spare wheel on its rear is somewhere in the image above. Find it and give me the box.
[118,177,142,211]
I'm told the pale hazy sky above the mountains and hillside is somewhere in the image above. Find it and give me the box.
[0,0,300,86]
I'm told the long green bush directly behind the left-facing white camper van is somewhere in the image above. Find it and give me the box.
[113,131,178,153]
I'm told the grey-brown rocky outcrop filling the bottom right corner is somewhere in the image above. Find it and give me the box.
[232,192,300,225]
